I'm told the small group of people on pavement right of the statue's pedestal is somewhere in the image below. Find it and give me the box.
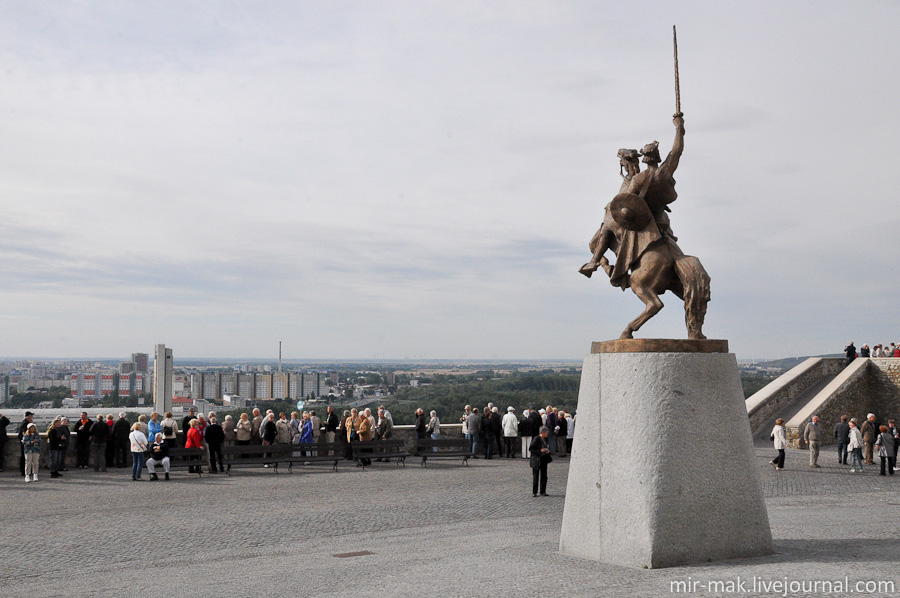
[771,413,900,475]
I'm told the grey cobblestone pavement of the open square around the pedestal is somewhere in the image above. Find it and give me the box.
[0,446,900,598]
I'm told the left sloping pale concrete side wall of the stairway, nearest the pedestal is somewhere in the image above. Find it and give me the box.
[745,357,843,434]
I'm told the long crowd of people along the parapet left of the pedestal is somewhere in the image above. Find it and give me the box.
[0,403,575,495]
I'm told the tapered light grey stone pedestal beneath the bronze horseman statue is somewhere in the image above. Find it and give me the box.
[551,340,773,568]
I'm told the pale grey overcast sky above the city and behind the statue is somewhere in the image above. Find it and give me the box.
[0,0,900,359]
